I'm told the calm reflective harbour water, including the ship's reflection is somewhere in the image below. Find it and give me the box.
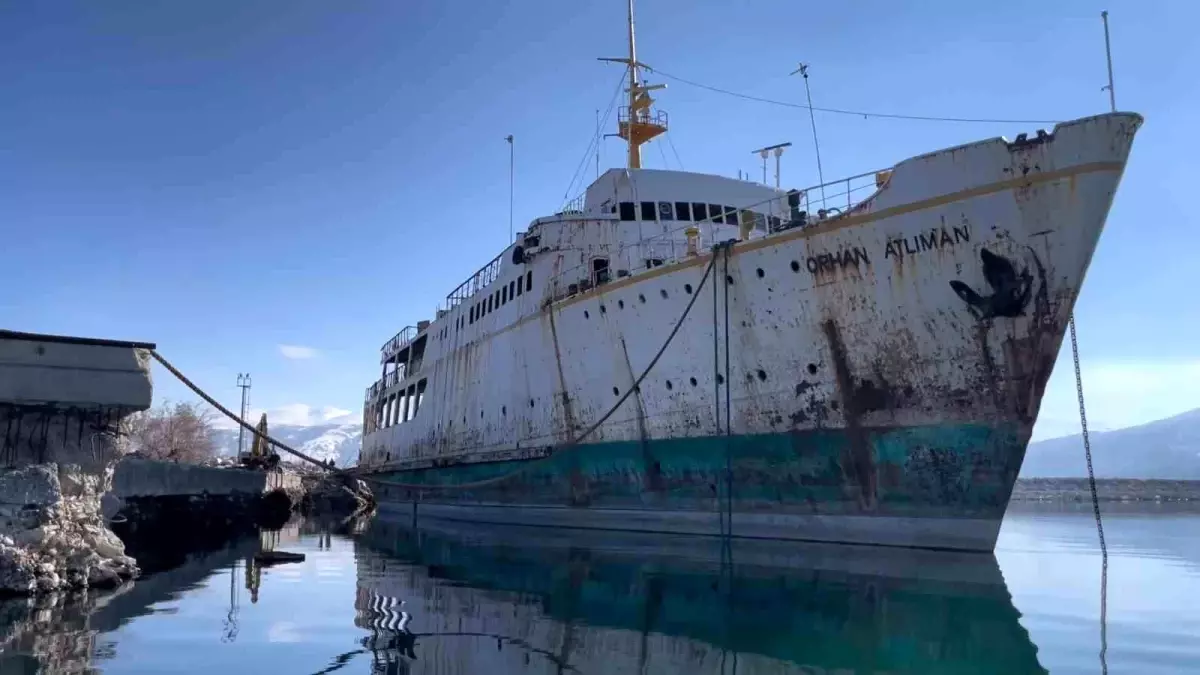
[0,512,1200,675]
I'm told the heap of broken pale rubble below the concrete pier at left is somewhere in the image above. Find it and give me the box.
[0,464,138,593]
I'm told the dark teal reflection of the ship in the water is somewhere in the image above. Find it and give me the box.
[350,511,1045,675]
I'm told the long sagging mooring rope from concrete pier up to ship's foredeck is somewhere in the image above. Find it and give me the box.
[150,249,732,490]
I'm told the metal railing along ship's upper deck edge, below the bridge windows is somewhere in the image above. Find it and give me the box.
[551,164,892,299]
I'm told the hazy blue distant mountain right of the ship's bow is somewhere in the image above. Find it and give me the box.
[1021,408,1200,480]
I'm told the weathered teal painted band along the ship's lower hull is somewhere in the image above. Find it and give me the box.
[369,424,1025,518]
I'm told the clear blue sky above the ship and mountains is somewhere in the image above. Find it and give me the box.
[0,0,1200,436]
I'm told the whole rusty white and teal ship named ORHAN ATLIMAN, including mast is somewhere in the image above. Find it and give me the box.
[356,2,1142,551]
